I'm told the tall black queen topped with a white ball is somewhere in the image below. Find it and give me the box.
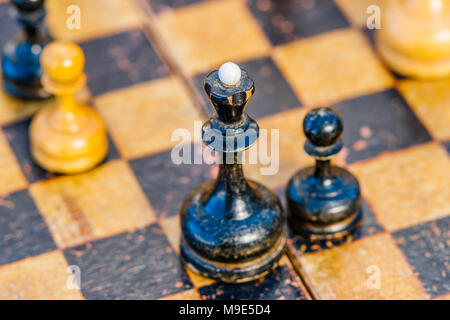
[180,62,286,283]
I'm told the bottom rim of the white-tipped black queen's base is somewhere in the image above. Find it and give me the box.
[180,235,286,283]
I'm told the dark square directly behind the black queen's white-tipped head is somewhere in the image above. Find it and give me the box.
[195,57,301,119]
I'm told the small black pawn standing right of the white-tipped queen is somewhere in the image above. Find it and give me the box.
[286,108,361,240]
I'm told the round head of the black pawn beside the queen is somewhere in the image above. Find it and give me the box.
[303,108,344,147]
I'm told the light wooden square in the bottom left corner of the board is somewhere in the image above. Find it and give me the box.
[0,251,84,300]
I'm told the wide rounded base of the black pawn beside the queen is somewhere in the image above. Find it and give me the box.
[286,166,362,240]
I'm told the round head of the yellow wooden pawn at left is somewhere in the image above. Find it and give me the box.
[41,41,84,83]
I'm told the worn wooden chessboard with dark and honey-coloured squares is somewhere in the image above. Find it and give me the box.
[0,0,450,299]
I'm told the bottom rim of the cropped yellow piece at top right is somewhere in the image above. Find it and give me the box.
[376,34,450,80]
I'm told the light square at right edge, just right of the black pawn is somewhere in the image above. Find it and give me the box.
[352,143,450,231]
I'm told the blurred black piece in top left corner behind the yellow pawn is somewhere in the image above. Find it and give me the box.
[2,0,51,99]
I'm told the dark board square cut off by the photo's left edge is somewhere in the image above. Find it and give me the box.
[0,190,56,265]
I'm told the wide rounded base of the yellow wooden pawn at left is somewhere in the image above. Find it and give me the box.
[30,106,108,174]
